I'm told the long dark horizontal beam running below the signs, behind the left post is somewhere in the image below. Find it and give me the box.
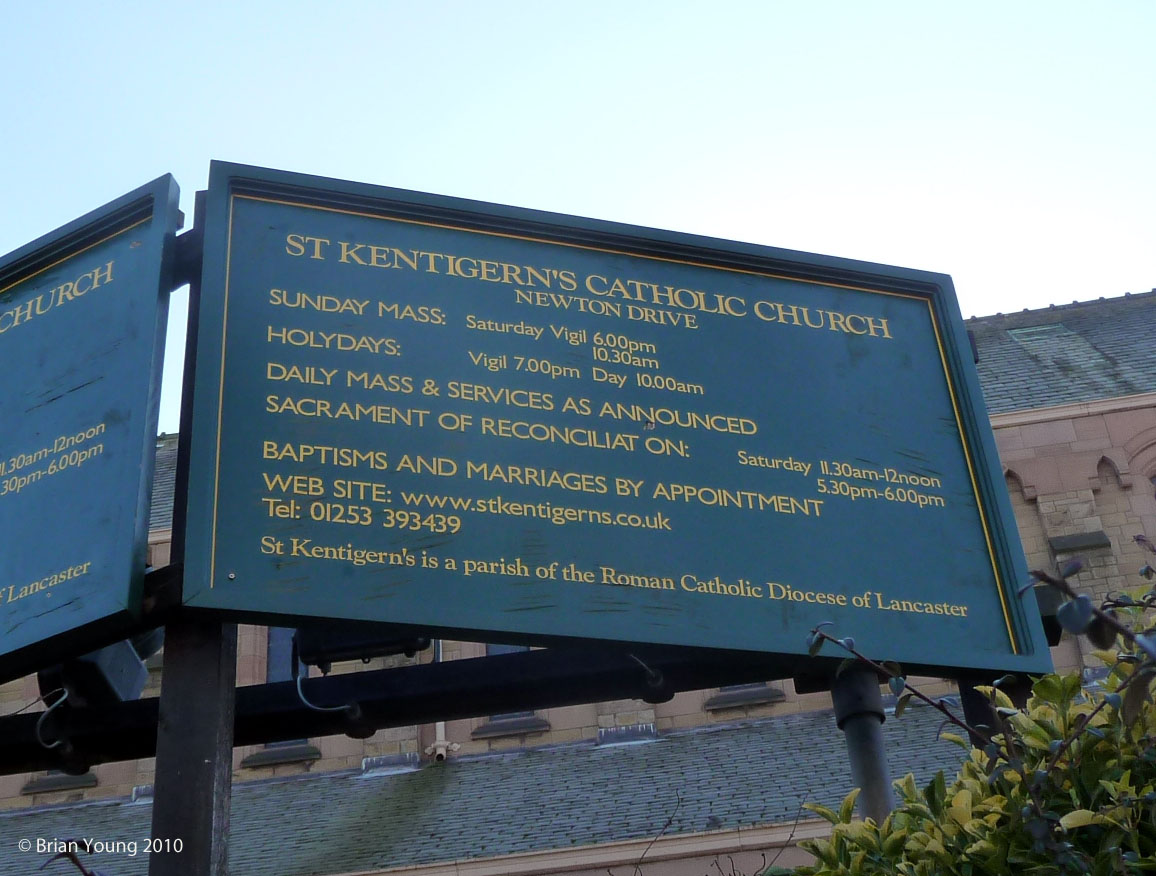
[0,647,791,776]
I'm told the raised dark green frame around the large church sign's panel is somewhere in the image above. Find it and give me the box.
[185,162,1051,675]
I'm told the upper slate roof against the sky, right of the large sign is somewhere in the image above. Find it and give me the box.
[966,289,1156,414]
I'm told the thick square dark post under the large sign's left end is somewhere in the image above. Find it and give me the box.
[148,619,237,876]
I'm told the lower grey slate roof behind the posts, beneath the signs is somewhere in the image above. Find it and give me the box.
[0,708,961,876]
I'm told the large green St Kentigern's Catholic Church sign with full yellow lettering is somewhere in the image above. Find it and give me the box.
[185,163,1050,670]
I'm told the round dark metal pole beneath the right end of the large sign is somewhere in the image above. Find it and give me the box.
[831,666,895,824]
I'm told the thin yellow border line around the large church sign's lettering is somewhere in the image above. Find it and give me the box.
[209,193,1021,655]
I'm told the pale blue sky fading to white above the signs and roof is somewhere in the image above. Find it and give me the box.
[0,0,1156,431]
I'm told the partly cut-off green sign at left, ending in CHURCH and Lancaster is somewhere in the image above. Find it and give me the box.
[0,176,179,678]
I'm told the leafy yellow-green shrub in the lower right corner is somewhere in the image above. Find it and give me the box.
[779,573,1156,876]
